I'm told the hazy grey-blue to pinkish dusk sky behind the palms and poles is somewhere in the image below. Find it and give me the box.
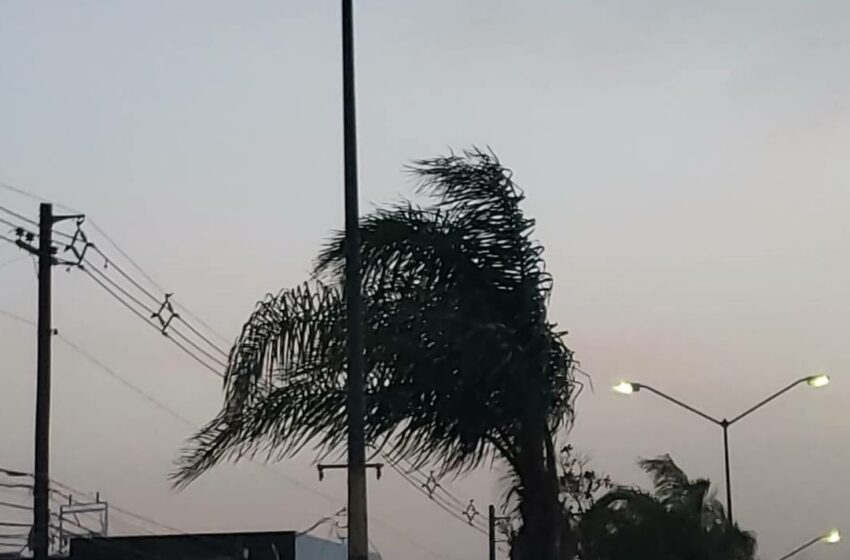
[0,0,850,560]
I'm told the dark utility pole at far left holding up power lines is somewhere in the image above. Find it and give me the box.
[32,203,53,560]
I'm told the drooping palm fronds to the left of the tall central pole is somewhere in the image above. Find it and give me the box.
[173,284,345,486]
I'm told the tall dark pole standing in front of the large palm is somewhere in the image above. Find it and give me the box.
[342,0,369,560]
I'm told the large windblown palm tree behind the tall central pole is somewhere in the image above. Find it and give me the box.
[176,149,574,560]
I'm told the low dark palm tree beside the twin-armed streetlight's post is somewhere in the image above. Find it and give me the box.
[578,455,756,560]
